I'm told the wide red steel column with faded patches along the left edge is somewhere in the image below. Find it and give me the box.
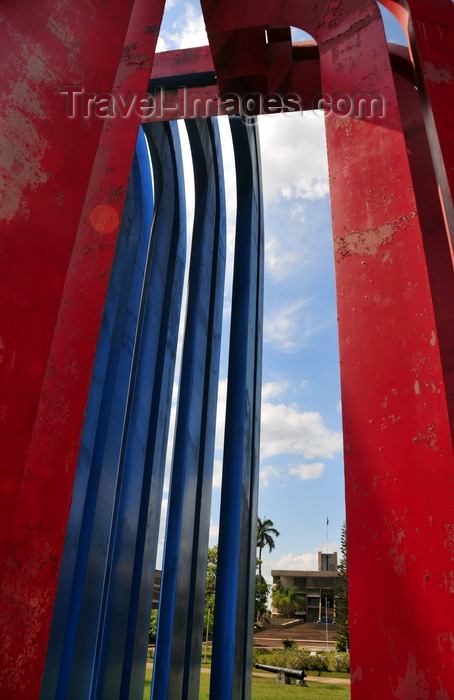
[0,0,164,699]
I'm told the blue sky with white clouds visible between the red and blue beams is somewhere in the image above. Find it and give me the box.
[157,0,406,582]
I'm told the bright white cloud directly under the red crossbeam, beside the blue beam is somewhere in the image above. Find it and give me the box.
[259,112,329,204]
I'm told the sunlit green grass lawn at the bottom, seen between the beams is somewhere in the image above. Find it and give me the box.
[143,668,350,700]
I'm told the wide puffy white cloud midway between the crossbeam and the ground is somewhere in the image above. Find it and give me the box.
[261,402,342,460]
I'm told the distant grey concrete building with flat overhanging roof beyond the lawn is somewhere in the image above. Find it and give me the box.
[271,552,344,622]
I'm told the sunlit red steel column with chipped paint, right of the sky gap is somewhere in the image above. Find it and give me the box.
[320,6,454,700]
